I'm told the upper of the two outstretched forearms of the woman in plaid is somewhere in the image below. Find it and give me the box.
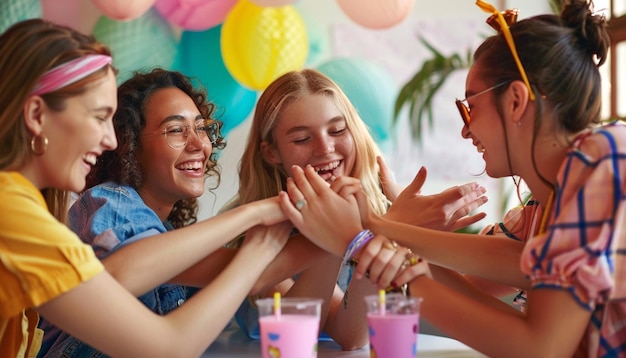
[367,217,530,288]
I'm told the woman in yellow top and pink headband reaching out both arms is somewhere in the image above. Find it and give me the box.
[0,19,288,357]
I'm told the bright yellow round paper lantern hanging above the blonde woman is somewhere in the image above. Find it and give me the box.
[221,0,309,90]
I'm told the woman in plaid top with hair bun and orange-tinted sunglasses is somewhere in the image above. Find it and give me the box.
[282,0,626,357]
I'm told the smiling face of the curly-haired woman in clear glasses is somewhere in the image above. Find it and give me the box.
[137,87,213,213]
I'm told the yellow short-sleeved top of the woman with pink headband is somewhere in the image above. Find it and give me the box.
[0,172,104,357]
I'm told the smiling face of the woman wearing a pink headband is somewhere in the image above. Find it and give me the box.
[32,70,117,192]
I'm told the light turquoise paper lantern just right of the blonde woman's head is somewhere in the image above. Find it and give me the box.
[318,57,398,142]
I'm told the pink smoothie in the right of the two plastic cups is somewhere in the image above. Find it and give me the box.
[367,313,419,358]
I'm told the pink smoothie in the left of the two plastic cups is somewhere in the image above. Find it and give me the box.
[259,314,320,358]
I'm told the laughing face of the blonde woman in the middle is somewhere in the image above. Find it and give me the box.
[261,94,356,181]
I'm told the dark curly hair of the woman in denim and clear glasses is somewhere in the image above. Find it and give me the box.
[87,68,226,228]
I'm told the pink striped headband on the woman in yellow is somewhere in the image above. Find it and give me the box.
[31,55,113,95]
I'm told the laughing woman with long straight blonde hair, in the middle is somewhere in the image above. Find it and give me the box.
[226,69,486,349]
